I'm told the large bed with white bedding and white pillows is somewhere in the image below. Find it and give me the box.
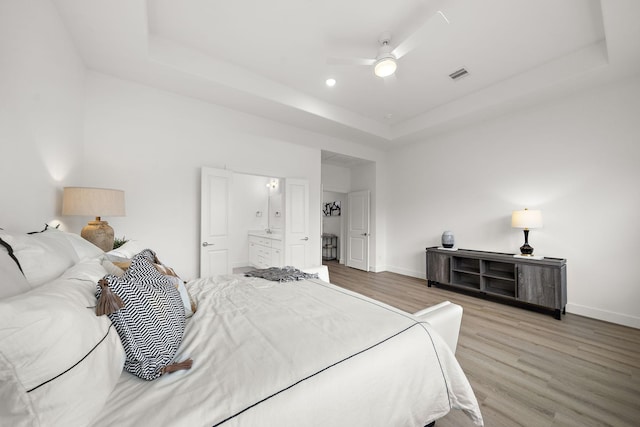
[0,230,483,427]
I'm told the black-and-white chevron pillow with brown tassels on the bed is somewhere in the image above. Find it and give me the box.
[96,249,190,380]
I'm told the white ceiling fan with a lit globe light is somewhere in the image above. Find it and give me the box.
[327,1,450,77]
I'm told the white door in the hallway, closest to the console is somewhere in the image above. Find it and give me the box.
[347,190,370,271]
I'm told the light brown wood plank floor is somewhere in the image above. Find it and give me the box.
[326,261,640,427]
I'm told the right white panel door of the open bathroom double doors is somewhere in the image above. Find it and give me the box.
[284,178,309,269]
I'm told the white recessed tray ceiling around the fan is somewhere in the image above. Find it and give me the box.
[54,0,640,148]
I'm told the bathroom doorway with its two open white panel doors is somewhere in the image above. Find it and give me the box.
[200,167,310,277]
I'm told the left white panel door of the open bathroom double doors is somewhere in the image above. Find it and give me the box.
[200,168,233,277]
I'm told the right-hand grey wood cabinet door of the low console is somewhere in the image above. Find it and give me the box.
[518,264,561,309]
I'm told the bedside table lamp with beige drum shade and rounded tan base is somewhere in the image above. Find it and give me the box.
[62,187,125,252]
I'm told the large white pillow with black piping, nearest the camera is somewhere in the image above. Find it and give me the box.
[0,263,125,426]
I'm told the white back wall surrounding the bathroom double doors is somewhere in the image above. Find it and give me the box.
[80,72,328,278]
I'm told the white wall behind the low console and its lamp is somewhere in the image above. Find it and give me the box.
[387,72,640,327]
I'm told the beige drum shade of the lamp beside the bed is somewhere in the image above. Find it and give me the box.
[62,187,125,217]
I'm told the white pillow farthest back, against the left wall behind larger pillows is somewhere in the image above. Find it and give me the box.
[0,230,79,287]
